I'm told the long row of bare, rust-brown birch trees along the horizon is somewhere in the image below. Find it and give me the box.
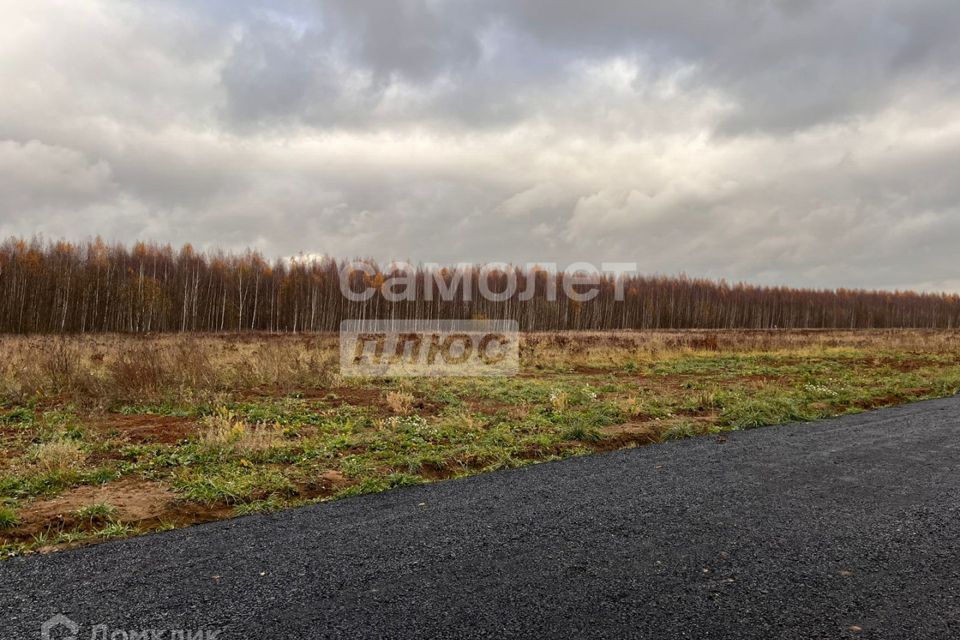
[0,238,960,333]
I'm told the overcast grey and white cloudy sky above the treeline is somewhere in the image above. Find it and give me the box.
[0,0,960,291]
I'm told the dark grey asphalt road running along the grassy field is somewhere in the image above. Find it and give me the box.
[0,398,960,640]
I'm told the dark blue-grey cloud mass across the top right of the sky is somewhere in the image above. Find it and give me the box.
[212,0,960,132]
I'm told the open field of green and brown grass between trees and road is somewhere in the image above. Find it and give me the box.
[0,331,960,556]
